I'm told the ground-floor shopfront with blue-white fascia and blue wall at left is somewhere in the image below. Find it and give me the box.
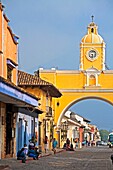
[0,77,42,158]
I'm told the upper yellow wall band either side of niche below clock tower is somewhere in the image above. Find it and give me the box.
[40,70,113,89]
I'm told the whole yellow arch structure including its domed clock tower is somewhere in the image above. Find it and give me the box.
[39,22,113,146]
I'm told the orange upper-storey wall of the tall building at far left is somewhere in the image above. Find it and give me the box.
[0,3,18,84]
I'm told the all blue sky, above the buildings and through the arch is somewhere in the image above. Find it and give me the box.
[2,0,113,130]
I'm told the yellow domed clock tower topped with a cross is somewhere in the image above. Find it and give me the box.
[80,16,105,71]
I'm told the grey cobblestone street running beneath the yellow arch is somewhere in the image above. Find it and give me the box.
[0,147,113,170]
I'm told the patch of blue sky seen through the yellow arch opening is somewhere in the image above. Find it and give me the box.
[70,99,113,131]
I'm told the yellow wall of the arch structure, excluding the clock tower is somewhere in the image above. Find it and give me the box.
[41,70,113,123]
